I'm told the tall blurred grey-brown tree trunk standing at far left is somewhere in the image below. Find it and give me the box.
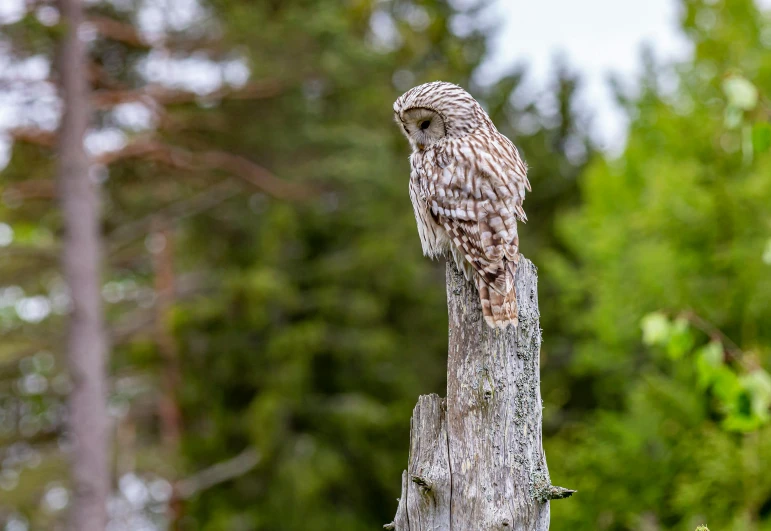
[57,0,109,531]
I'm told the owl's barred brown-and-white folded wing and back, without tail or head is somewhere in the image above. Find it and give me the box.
[424,132,530,295]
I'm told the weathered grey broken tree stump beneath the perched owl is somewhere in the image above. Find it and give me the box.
[385,257,574,531]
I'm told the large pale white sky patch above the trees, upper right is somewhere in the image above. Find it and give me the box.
[480,0,692,152]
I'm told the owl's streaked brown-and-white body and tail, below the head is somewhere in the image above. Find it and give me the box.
[410,129,530,327]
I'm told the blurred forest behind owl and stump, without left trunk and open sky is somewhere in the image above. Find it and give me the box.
[0,0,771,531]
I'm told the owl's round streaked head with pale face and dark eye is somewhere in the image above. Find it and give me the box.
[394,81,492,151]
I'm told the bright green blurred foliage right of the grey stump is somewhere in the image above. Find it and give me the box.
[542,0,771,530]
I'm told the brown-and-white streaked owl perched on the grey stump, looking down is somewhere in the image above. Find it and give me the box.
[394,81,530,328]
